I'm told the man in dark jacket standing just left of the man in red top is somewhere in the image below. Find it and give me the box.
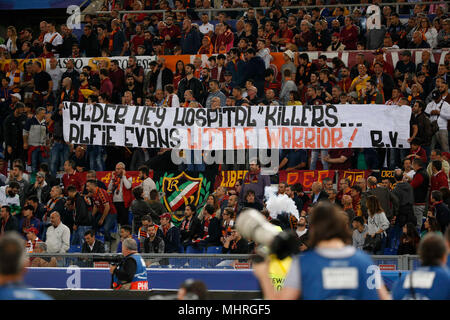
[67,185,92,244]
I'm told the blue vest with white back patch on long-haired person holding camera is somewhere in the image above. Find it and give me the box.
[284,246,382,300]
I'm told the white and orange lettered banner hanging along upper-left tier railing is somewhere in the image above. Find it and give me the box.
[45,56,157,72]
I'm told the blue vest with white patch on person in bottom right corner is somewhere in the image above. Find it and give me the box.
[392,266,450,300]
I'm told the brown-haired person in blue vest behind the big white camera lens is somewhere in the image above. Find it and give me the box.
[254,202,390,300]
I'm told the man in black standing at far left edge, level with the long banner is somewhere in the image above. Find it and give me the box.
[3,102,27,164]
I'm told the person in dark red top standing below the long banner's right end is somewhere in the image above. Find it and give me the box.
[410,159,430,228]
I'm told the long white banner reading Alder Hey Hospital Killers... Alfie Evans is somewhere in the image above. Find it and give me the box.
[63,102,411,150]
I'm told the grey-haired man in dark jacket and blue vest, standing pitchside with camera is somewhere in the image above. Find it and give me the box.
[109,238,148,290]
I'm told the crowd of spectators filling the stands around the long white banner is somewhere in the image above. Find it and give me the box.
[0,0,450,265]
